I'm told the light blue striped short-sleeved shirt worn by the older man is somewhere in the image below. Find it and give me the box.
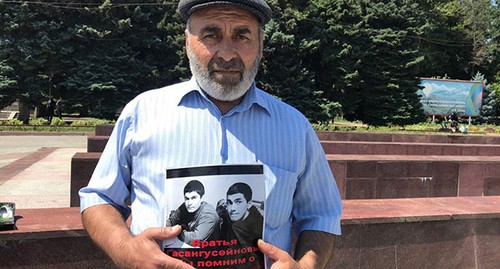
[80,79,342,255]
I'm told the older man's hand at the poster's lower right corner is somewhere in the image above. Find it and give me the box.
[257,240,314,269]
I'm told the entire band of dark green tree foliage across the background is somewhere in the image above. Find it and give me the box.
[0,0,500,125]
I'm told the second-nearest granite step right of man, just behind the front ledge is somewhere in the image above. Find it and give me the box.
[327,154,500,199]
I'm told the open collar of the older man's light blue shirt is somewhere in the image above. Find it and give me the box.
[177,77,271,115]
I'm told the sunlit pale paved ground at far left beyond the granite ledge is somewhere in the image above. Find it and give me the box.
[0,134,87,208]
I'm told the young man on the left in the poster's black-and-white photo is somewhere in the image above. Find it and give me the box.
[166,180,219,245]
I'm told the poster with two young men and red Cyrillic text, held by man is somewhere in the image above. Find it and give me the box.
[162,164,266,269]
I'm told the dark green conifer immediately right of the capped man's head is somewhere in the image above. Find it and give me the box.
[257,1,336,121]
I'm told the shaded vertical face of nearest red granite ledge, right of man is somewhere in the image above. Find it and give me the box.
[327,218,500,269]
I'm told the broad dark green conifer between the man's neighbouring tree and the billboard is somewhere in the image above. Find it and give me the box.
[311,1,423,125]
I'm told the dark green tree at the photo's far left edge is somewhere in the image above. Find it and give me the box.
[0,1,72,123]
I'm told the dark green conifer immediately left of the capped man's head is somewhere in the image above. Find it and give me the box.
[56,1,186,119]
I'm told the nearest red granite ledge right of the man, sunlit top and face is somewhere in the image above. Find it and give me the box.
[334,196,500,268]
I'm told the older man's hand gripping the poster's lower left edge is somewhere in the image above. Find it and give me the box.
[113,225,193,269]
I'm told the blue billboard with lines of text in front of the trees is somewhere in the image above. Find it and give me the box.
[417,78,484,116]
